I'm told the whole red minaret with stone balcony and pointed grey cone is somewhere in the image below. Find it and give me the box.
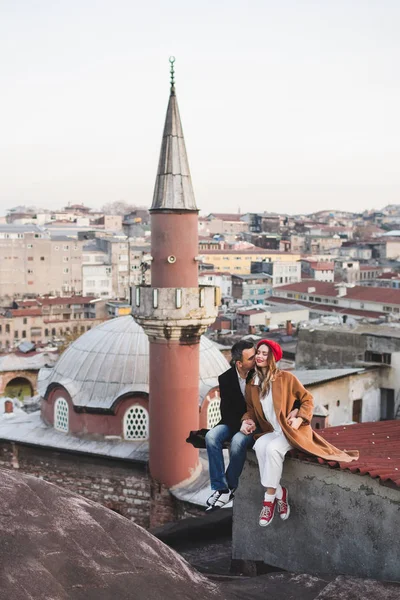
[132,57,217,487]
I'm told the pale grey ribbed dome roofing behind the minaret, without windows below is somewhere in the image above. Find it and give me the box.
[38,316,229,409]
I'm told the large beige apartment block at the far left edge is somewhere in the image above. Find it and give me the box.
[0,224,83,298]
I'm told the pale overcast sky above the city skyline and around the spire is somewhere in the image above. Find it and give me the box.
[0,0,400,215]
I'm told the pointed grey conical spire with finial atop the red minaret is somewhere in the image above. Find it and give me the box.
[150,56,197,211]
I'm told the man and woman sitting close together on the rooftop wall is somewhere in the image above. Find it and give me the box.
[206,340,358,527]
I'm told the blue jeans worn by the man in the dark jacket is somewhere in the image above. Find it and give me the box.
[206,425,254,490]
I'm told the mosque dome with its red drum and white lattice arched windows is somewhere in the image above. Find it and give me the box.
[38,316,229,440]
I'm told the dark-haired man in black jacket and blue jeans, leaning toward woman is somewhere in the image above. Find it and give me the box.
[205,340,256,512]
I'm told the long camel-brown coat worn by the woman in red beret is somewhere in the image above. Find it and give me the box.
[242,371,358,462]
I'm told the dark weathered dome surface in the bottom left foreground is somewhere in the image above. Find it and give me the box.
[0,470,220,600]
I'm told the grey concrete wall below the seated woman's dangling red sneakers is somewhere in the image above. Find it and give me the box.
[232,452,400,581]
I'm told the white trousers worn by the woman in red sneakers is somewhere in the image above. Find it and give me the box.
[254,431,293,488]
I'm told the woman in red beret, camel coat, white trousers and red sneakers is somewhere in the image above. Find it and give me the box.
[241,340,358,527]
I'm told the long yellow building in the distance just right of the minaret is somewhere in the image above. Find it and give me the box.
[201,247,300,275]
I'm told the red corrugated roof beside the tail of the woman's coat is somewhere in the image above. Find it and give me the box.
[292,420,400,487]
